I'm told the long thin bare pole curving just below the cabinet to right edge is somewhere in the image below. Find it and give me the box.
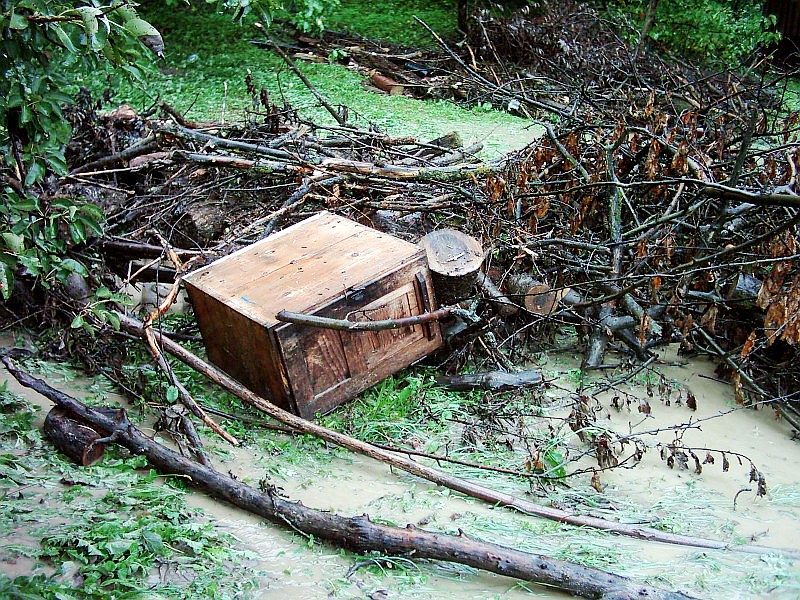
[117,313,800,558]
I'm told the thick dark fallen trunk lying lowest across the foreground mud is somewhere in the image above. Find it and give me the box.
[2,357,692,600]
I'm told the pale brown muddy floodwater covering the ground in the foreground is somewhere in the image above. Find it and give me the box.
[0,346,800,599]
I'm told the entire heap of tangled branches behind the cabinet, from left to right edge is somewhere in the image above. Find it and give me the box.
[7,3,800,429]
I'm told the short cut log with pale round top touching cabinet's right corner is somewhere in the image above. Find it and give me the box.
[420,229,483,305]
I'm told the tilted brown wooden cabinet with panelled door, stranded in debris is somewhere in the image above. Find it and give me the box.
[184,213,441,418]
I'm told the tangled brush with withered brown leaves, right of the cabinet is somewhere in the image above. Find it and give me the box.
[438,2,800,428]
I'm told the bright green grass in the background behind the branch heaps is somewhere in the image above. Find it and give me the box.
[112,2,537,156]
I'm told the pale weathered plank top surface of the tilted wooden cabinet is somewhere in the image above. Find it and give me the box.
[184,212,425,327]
